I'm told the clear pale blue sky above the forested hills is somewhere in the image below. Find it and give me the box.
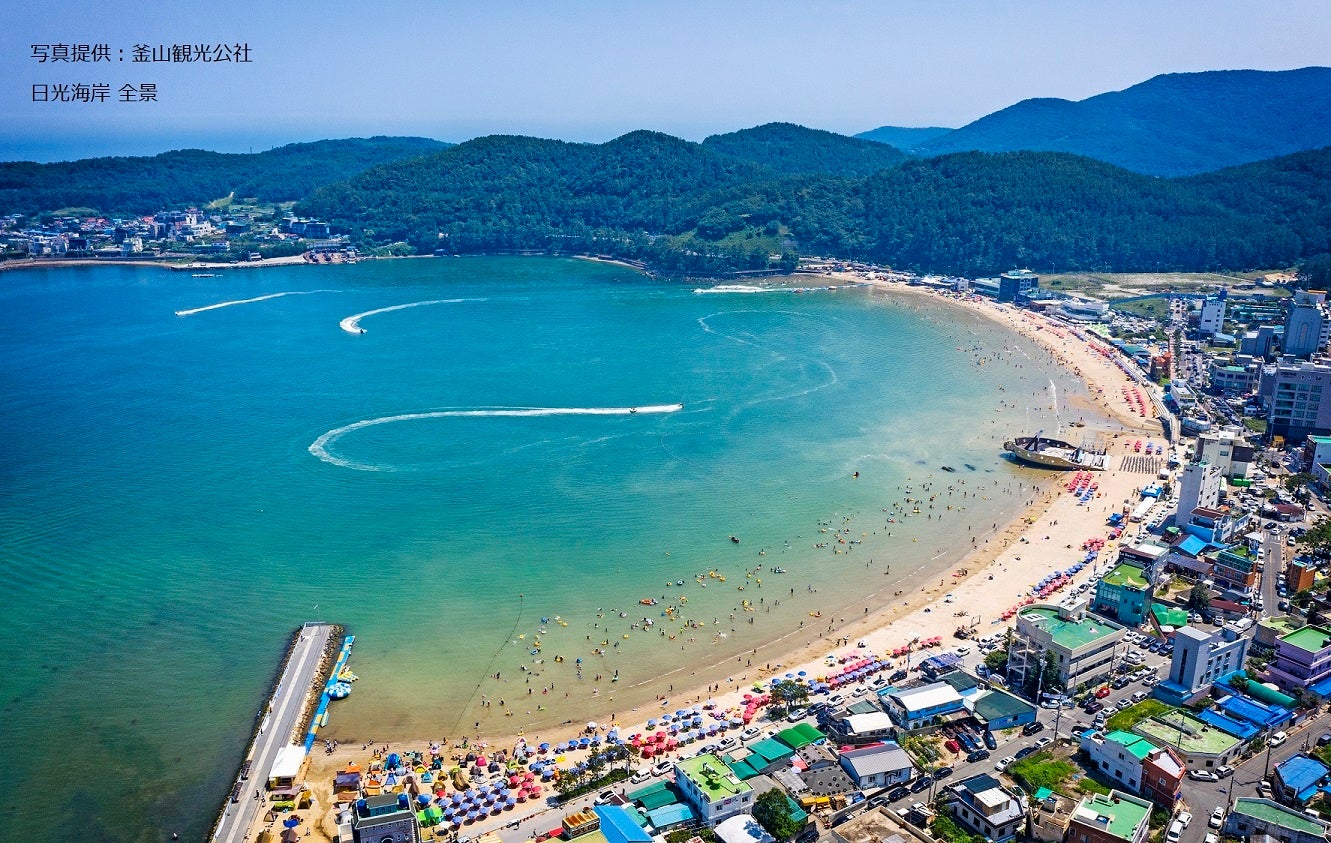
[0,0,1331,160]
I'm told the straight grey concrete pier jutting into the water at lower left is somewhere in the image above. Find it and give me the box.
[213,623,333,843]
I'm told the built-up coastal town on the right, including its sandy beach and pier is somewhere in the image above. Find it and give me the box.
[214,266,1331,843]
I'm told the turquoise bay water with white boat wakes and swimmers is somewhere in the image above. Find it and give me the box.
[0,258,1079,840]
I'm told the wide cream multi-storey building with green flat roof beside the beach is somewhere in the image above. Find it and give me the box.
[1008,601,1126,690]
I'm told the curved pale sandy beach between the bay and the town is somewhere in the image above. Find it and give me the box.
[294,274,1163,836]
